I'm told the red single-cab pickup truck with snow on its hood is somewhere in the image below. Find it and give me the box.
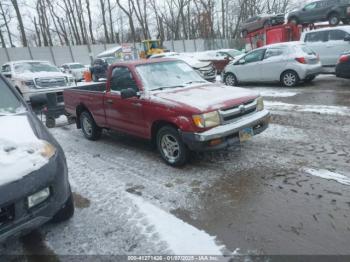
[64,59,270,166]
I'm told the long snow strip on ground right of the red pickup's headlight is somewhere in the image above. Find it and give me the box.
[265,101,350,116]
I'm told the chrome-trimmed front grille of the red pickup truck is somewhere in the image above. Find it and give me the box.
[219,100,257,124]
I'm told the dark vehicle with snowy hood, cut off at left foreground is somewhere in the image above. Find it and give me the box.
[0,74,74,242]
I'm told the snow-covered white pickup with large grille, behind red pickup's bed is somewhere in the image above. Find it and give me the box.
[1,60,75,101]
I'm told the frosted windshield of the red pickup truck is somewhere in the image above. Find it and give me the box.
[136,61,206,91]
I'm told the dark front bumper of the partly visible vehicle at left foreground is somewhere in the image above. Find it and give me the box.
[0,152,71,242]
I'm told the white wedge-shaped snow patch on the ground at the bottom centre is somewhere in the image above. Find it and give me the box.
[129,195,224,255]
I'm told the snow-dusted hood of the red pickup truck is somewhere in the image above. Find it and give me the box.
[153,84,259,113]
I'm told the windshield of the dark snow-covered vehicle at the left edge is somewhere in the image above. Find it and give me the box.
[0,78,26,116]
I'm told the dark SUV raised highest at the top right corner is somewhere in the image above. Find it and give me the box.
[288,0,350,26]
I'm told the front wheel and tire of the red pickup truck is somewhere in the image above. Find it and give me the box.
[156,126,190,167]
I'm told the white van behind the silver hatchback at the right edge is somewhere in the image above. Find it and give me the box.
[301,26,350,73]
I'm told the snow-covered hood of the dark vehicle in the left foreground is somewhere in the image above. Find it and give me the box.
[0,113,48,186]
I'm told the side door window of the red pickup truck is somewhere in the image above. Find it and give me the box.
[111,67,138,91]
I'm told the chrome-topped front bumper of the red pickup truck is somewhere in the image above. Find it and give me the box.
[182,110,271,151]
